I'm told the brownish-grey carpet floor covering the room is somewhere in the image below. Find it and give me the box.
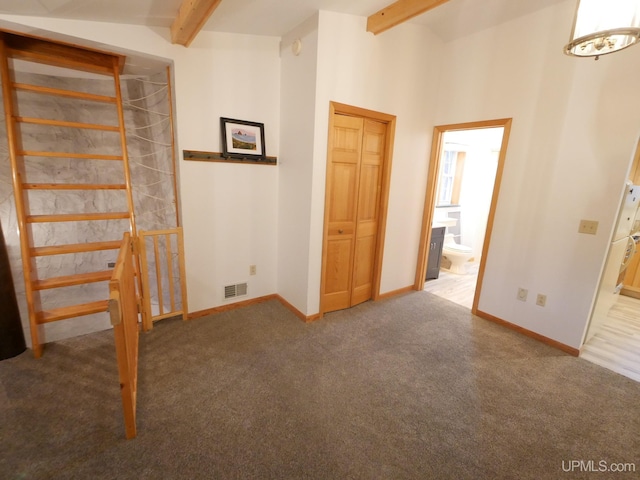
[0,292,640,480]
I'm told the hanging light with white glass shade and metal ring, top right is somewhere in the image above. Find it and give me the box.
[564,0,640,60]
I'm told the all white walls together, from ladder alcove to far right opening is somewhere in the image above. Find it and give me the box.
[0,0,640,347]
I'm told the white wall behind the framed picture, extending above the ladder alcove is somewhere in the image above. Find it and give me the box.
[0,15,280,318]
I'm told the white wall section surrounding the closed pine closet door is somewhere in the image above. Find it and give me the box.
[309,11,442,313]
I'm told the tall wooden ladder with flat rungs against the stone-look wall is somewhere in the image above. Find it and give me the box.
[0,32,136,358]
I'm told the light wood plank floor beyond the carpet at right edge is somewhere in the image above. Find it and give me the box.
[580,295,640,382]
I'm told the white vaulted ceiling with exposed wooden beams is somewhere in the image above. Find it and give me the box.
[0,0,571,43]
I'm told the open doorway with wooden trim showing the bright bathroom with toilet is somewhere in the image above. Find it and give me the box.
[414,119,511,313]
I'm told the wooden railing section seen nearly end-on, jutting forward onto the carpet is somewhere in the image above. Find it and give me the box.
[109,233,138,439]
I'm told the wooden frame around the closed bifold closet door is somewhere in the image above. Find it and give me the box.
[319,102,396,318]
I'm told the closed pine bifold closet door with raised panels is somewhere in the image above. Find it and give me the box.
[322,113,387,312]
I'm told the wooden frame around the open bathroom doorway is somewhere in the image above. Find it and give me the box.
[414,118,512,314]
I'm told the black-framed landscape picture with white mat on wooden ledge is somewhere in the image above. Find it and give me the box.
[220,117,267,161]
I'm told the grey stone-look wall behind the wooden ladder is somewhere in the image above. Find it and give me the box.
[0,67,179,342]
